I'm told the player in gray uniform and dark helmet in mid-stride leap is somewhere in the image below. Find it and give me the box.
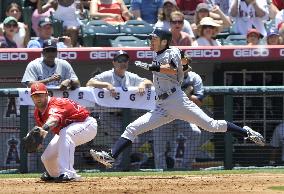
[90,28,265,167]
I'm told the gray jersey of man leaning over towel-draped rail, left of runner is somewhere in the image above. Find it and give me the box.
[92,69,145,87]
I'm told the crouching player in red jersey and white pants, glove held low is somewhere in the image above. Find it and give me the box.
[22,82,97,182]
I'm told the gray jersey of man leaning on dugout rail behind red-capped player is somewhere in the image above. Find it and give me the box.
[22,57,78,86]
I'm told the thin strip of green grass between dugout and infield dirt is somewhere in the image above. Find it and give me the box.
[0,169,284,178]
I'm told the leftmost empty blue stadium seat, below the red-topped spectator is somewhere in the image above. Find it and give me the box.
[81,20,124,46]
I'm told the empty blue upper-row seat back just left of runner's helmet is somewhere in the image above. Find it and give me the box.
[120,20,153,39]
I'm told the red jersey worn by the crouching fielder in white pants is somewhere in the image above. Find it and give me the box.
[34,97,90,134]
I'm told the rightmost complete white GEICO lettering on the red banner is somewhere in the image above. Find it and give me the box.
[233,48,269,57]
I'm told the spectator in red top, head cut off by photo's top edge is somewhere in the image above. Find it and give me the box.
[90,0,133,25]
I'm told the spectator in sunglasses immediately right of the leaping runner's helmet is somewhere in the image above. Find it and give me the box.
[170,11,193,46]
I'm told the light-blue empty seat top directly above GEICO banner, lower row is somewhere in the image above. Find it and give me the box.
[111,36,149,47]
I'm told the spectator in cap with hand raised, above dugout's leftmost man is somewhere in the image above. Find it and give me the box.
[27,17,72,48]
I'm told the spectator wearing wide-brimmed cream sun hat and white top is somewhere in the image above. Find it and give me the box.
[193,17,221,46]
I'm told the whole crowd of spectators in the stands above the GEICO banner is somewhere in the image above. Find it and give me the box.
[0,0,284,48]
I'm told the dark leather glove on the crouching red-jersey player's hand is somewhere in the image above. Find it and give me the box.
[22,126,44,153]
